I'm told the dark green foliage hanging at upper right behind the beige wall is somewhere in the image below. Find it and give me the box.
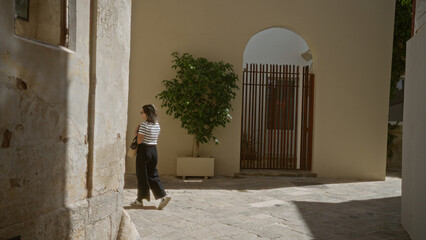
[390,0,413,98]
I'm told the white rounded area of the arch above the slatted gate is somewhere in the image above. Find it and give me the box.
[244,28,310,66]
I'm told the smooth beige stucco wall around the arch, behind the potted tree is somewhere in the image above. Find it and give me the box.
[126,0,394,179]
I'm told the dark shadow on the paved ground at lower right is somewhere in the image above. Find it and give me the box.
[293,197,410,240]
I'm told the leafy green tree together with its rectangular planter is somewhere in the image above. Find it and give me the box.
[156,52,238,177]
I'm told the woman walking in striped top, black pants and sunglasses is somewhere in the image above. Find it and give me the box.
[130,104,171,209]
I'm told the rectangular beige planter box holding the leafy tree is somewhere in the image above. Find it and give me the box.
[176,157,214,178]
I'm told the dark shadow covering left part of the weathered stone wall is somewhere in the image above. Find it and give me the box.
[0,1,72,239]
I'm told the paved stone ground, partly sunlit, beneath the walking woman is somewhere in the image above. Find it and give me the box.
[124,174,410,240]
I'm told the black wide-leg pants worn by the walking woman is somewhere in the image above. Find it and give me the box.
[136,143,166,201]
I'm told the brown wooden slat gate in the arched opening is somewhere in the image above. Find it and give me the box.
[240,64,314,170]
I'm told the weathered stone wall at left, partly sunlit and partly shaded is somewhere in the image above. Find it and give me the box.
[0,0,131,239]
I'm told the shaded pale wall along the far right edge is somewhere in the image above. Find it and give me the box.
[402,9,426,240]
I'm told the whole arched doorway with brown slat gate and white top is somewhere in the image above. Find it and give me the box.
[240,28,314,170]
